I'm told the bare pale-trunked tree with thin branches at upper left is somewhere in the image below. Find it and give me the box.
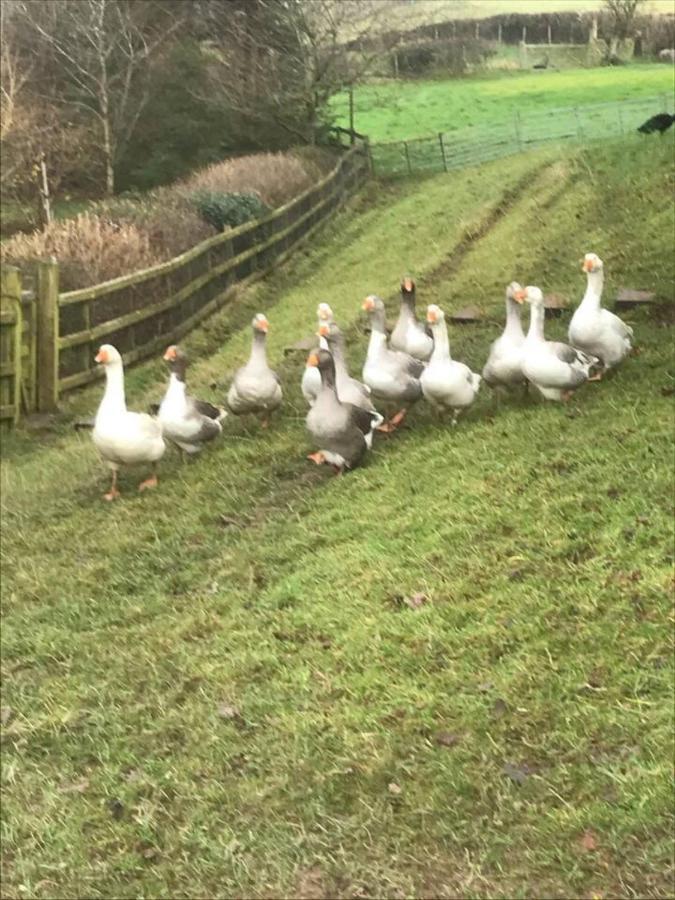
[21,0,186,194]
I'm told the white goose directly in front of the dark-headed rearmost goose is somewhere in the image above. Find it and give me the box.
[420,304,481,425]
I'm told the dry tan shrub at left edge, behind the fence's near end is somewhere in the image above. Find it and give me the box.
[0,213,162,291]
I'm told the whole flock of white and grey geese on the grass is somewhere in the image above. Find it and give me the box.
[92,253,633,500]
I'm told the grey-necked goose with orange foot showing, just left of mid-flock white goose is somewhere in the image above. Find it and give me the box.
[363,294,424,431]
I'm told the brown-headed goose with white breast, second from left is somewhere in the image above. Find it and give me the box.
[158,344,227,454]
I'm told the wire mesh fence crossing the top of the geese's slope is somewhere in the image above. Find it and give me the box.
[370,94,674,177]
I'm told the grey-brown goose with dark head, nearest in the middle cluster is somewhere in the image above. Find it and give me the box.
[306,348,381,475]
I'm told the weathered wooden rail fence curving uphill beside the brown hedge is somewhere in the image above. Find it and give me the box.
[0,140,369,421]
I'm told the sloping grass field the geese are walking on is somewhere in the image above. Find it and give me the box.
[2,138,673,897]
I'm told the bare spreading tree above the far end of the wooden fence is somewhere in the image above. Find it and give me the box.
[195,0,396,143]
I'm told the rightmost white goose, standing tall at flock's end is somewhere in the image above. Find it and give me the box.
[568,253,633,381]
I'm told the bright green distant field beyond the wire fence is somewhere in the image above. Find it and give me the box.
[333,65,673,141]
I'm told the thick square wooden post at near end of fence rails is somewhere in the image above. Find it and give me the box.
[37,256,59,412]
